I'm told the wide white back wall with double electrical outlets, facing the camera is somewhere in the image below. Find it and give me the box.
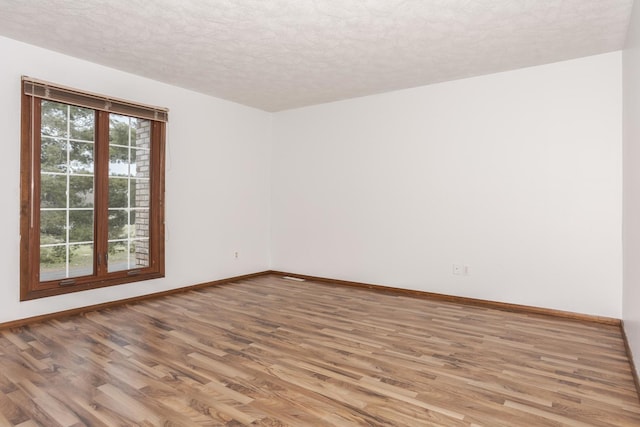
[271,52,622,318]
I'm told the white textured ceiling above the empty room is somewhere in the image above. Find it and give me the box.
[0,0,633,111]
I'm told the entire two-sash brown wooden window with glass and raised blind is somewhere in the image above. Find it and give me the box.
[20,77,167,300]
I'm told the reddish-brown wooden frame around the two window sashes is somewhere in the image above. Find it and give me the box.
[20,78,167,301]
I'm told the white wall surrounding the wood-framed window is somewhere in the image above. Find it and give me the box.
[0,38,272,322]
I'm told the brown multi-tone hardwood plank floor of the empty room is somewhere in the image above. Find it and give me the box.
[0,276,640,427]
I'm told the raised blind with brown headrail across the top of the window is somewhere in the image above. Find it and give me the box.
[22,76,169,122]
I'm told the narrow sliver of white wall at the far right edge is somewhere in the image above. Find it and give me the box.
[622,1,640,375]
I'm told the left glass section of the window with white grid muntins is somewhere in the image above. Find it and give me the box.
[40,101,95,281]
